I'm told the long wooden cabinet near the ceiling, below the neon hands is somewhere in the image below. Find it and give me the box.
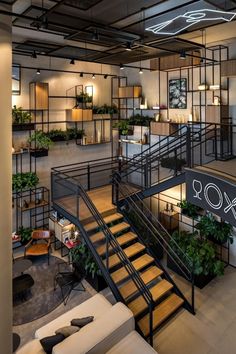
[150,51,201,71]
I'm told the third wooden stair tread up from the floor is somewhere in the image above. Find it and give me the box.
[119,266,163,299]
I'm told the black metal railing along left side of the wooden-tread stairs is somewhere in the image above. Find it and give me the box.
[51,170,154,345]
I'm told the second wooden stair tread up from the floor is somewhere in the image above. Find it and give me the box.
[128,279,173,317]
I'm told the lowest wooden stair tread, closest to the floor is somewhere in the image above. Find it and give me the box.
[138,293,184,336]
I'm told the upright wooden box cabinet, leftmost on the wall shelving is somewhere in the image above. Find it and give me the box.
[29,82,49,110]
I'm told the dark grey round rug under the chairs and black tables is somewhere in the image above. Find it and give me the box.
[13,256,70,326]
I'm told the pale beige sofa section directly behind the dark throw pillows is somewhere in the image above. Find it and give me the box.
[35,294,112,339]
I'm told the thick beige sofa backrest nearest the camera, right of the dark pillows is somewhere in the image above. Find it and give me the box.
[53,302,134,354]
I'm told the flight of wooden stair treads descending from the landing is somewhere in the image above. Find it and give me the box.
[83,211,184,337]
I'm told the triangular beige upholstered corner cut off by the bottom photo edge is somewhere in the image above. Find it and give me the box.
[106,331,157,354]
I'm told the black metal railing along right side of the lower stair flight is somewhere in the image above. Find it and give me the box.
[112,173,195,314]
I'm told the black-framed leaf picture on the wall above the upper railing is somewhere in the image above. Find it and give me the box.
[169,79,187,109]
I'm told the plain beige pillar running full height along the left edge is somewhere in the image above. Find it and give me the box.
[0,4,12,354]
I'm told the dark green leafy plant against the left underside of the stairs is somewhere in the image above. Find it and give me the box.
[71,243,102,278]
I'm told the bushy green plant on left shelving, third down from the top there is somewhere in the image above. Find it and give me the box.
[12,172,39,192]
